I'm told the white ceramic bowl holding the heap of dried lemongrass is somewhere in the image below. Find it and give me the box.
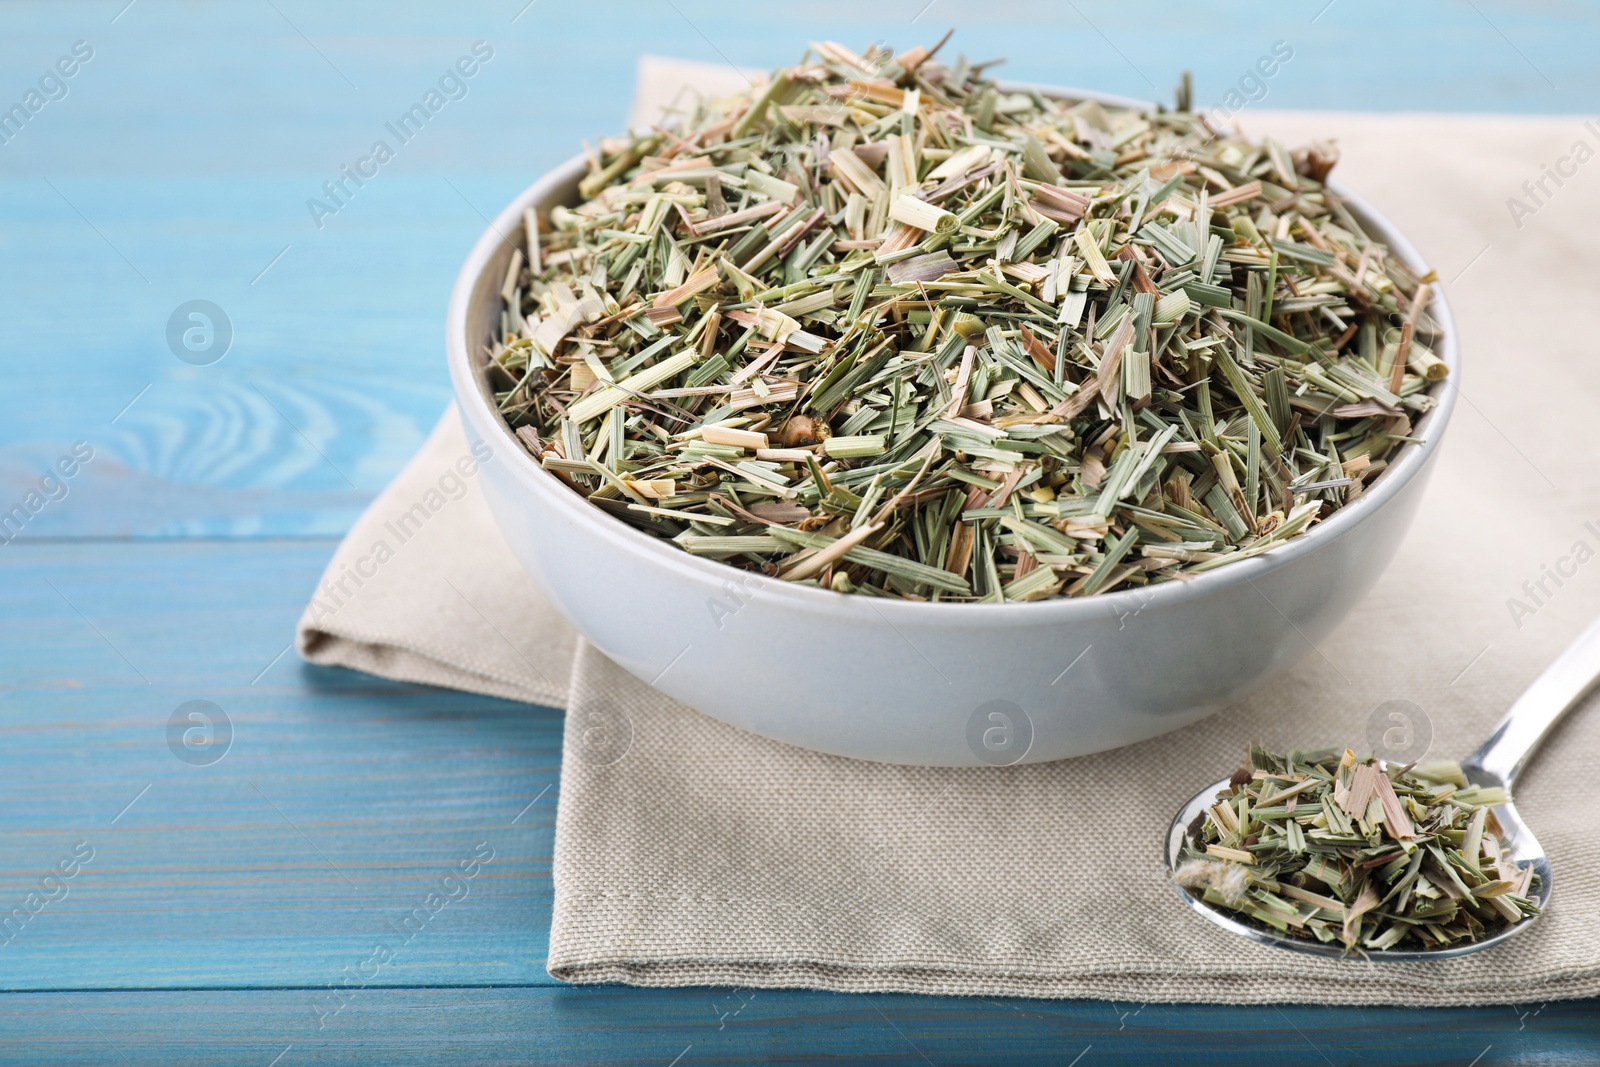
[446,90,1461,766]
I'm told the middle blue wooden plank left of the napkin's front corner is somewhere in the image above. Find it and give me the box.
[0,541,562,990]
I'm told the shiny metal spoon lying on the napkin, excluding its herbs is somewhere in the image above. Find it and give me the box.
[1166,622,1600,960]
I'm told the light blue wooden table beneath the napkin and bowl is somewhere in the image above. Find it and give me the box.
[0,0,1600,1067]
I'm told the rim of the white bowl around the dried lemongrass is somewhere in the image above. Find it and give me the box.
[445,82,1461,627]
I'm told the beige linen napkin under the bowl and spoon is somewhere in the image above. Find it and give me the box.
[299,62,1600,1005]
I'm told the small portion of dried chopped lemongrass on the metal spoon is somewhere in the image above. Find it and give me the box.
[1173,745,1539,952]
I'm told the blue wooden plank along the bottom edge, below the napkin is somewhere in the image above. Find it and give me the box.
[0,987,1600,1067]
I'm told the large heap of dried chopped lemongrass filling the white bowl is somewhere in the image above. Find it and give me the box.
[488,43,1446,601]
